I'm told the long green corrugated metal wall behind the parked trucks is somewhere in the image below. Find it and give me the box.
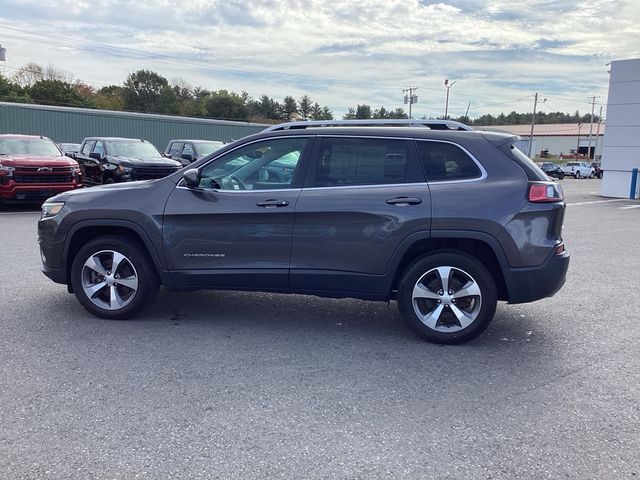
[0,102,267,151]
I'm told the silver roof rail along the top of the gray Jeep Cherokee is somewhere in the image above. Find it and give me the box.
[263,118,473,132]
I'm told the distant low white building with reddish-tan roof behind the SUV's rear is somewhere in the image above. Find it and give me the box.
[474,123,604,159]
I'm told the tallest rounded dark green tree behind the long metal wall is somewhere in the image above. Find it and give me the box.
[124,70,178,113]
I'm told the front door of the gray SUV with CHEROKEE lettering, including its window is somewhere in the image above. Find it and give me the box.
[163,137,311,291]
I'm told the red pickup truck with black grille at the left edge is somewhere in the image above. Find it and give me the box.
[0,135,82,202]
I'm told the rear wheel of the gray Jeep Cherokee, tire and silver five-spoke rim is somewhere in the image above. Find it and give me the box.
[398,252,497,344]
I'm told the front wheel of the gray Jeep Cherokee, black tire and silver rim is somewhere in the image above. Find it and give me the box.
[71,235,159,320]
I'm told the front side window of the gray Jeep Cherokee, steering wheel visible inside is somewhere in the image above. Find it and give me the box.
[200,138,307,190]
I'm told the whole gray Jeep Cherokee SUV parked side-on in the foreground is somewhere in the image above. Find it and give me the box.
[38,121,569,343]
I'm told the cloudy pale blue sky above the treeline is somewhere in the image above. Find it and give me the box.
[0,0,640,118]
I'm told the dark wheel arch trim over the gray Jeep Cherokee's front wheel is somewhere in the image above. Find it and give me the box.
[63,220,171,288]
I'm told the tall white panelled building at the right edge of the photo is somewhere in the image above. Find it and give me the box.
[602,59,640,198]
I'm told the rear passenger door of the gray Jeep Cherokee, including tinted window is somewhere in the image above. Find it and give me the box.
[291,136,431,293]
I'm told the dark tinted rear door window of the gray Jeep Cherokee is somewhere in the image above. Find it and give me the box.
[311,138,424,187]
